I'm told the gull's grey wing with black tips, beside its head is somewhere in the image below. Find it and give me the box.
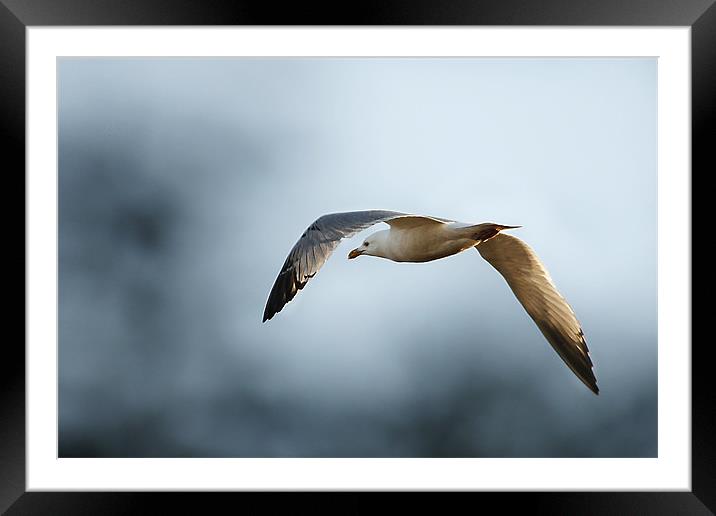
[263,210,406,322]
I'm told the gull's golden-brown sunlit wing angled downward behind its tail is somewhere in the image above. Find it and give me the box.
[475,233,599,394]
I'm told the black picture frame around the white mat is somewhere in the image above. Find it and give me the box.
[0,0,716,514]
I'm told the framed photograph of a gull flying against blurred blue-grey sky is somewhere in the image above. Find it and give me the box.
[56,56,660,459]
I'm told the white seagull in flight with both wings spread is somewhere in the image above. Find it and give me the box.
[263,210,599,394]
